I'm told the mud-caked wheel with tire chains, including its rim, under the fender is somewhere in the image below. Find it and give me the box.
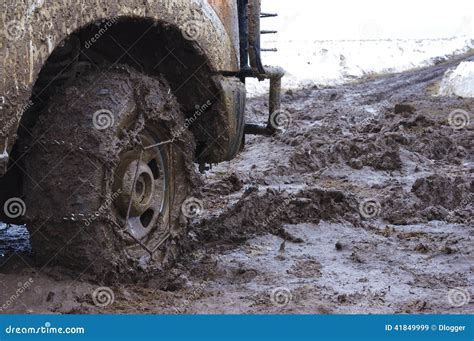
[25,69,196,280]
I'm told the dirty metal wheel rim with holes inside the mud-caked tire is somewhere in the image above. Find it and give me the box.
[113,132,169,240]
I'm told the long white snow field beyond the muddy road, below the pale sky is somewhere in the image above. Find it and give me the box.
[247,37,474,97]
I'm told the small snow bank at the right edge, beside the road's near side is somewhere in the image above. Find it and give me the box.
[439,62,474,98]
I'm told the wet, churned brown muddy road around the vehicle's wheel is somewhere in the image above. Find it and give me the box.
[0,54,474,314]
